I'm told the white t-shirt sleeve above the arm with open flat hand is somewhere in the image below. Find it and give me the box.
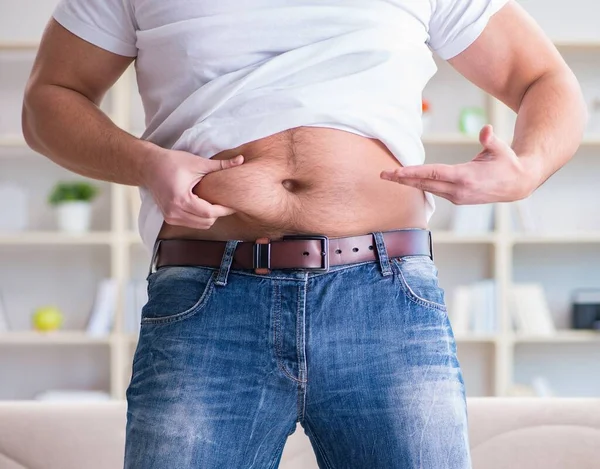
[428,0,509,60]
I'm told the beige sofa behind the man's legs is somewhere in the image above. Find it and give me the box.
[0,398,600,469]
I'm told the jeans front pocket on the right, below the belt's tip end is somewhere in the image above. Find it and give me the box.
[390,256,447,313]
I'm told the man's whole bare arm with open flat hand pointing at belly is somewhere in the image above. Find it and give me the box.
[382,1,587,204]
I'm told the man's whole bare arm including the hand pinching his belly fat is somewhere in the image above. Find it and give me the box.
[22,19,241,229]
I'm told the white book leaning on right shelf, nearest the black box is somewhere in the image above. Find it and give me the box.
[509,283,556,335]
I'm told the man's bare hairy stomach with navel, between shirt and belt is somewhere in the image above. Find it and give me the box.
[159,127,427,241]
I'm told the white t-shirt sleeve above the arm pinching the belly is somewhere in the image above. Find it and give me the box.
[52,0,137,57]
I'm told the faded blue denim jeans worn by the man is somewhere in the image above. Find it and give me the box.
[125,232,471,469]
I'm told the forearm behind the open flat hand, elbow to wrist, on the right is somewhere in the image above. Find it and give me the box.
[512,71,587,192]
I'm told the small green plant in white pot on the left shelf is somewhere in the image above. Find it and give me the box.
[48,181,98,233]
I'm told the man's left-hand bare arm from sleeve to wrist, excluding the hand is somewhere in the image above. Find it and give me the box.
[22,20,148,185]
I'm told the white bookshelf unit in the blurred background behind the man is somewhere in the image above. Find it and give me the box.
[0,0,600,400]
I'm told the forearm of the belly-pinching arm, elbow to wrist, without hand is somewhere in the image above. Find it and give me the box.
[23,85,164,186]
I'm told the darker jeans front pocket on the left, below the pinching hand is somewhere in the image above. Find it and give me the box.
[141,266,217,325]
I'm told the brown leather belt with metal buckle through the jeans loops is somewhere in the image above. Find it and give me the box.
[150,229,433,274]
